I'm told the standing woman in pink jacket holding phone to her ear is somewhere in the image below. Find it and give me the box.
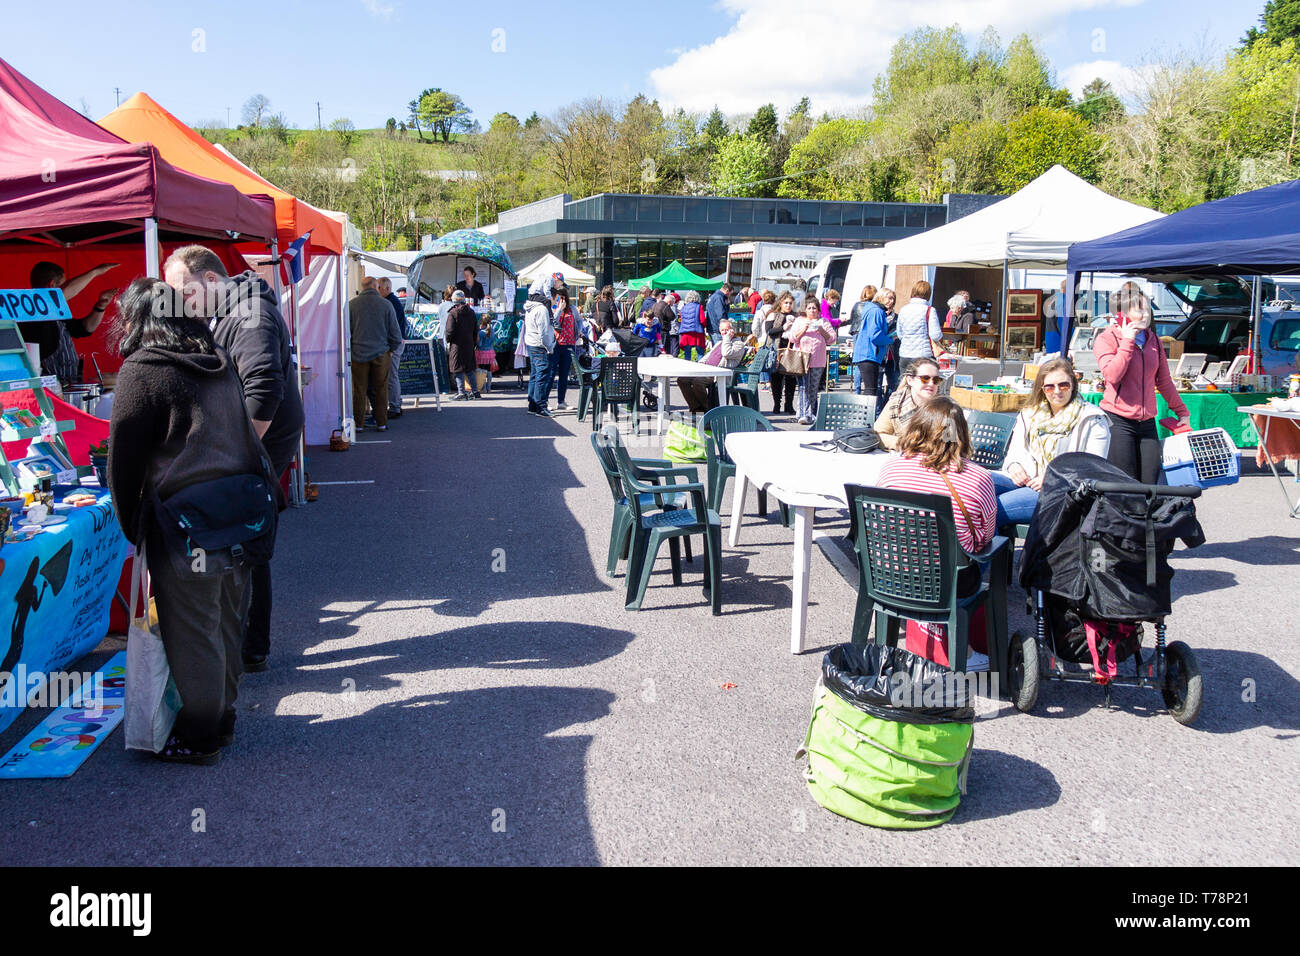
[1092,282,1191,485]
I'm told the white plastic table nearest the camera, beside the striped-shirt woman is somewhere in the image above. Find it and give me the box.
[727,431,894,654]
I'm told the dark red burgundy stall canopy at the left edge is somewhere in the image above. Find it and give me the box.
[0,60,276,245]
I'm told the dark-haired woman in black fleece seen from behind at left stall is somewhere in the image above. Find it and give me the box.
[108,278,265,763]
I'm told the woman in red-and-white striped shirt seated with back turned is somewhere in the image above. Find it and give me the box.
[876,398,997,665]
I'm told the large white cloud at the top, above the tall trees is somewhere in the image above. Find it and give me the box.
[650,0,1143,113]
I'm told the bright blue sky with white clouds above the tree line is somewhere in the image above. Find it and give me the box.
[0,0,1264,127]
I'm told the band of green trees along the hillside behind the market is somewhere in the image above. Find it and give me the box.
[207,0,1300,248]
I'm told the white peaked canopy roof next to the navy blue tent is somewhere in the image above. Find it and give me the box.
[884,165,1162,268]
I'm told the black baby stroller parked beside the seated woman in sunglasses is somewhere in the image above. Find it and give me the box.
[1008,453,1205,724]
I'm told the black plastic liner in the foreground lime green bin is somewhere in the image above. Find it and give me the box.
[822,644,975,723]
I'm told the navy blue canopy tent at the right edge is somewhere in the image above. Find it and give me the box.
[1062,179,1300,351]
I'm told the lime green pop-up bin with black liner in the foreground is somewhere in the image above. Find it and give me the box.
[798,644,975,830]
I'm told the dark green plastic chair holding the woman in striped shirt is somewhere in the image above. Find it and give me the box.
[844,485,1011,671]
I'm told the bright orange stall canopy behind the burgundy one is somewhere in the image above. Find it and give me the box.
[99,92,343,254]
